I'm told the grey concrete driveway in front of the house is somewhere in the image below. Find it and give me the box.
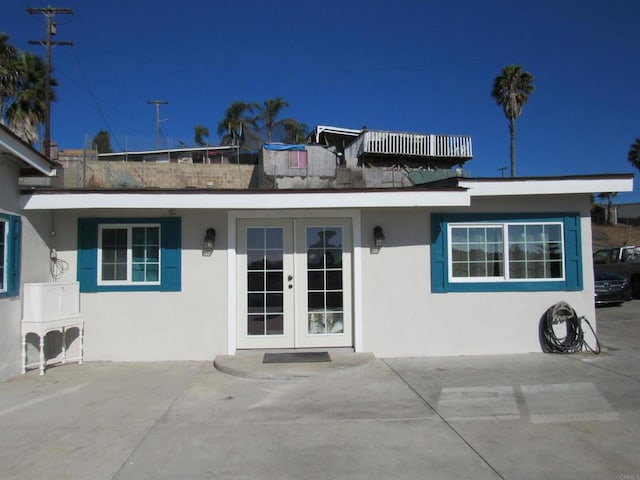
[0,300,640,480]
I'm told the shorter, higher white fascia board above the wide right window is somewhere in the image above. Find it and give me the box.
[459,176,633,197]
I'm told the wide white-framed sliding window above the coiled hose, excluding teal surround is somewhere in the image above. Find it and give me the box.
[448,222,565,283]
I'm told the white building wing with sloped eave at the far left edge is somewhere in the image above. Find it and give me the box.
[0,125,56,381]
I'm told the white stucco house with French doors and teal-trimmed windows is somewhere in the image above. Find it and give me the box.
[0,125,633,377]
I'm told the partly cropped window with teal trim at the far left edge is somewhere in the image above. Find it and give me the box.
[0,213,22,297]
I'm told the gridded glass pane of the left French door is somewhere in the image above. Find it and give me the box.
[246,227,284,336]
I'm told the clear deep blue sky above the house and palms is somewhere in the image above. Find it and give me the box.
[0,0,640,201]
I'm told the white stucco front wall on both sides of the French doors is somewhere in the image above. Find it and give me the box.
[36,191,595,361]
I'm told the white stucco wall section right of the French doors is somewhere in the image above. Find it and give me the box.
[362,195,595,356]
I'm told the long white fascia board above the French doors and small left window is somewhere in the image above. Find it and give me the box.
[21,189,471,210]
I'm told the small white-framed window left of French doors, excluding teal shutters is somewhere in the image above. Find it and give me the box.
[98,223,161,285]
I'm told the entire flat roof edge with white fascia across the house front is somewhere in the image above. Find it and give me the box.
[21,174,633,210]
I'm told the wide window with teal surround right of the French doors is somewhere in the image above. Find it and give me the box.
[431,213,583,293]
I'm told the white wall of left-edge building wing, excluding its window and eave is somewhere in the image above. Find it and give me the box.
[0,160,50,381]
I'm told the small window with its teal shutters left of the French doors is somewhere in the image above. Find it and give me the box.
[78,218,182,292]
